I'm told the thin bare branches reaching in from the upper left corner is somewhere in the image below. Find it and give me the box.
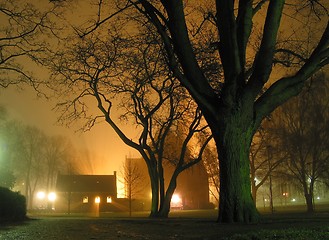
[0,0,60,89]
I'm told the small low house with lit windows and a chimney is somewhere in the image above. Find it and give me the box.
[55,172,118,214]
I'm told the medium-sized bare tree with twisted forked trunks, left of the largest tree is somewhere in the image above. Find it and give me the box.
[45,26,208,217]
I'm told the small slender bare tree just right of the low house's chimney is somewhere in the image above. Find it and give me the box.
[122,158,146,216]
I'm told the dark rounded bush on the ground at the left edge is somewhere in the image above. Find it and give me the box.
[0,187,26,222]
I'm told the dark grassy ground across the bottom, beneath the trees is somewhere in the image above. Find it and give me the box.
[0,211,329,240]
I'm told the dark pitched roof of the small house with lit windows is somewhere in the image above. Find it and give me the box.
[56,174,117,195]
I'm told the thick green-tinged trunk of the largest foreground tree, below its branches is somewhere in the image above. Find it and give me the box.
[213,110,259,223]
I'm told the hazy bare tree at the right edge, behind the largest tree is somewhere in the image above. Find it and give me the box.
[275,75,329,212]
